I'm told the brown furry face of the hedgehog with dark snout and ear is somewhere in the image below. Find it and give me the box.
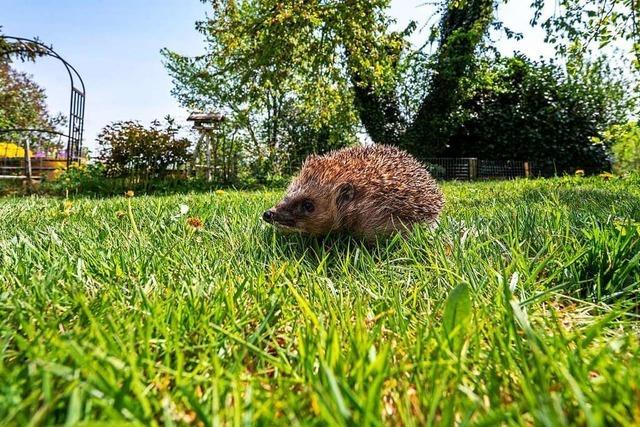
[263,178,354,235]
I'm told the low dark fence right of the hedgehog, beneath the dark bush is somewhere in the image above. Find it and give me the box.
[426,157,535,180]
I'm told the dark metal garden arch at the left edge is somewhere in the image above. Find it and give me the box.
[0,35,85,167]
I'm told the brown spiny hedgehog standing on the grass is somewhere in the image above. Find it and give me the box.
[262,144,444,240]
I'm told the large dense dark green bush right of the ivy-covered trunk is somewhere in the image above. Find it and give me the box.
[445,56,630,175]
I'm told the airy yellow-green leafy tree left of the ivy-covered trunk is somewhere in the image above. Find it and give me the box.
[163,1,357,179]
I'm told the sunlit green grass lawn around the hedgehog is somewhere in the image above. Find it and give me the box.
[0,177,640,426]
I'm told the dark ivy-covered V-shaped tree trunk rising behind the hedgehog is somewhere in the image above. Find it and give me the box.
[347,0,494,158]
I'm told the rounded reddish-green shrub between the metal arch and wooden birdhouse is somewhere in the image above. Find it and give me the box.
[97,117,191,178]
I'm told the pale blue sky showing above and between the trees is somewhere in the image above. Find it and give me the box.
[0,0,552,154]
